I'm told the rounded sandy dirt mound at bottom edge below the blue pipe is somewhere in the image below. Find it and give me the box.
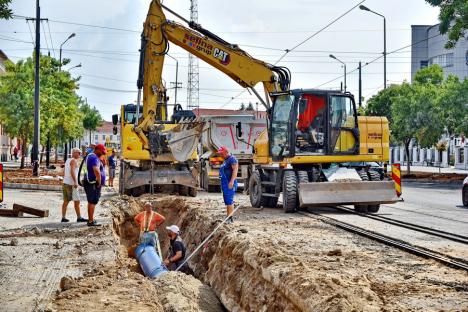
[154,272,224,312]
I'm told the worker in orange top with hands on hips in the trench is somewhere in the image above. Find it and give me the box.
[135,203,166,252]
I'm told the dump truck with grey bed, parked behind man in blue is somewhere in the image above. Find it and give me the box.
[199,115,266,192]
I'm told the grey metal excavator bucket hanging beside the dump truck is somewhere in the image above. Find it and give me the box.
[168,120,203,162]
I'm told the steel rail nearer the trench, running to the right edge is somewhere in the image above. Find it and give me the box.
[299,211,468,271]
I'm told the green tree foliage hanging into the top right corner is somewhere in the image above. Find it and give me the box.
[426,0,468,49]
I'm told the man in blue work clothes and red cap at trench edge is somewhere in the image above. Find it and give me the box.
[218,146,239,223]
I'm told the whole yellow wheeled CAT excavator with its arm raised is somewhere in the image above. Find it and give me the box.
[122,0,397,212]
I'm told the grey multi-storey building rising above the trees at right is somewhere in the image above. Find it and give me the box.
[411,24,468,80]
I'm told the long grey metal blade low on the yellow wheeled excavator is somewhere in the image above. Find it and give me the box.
[299,181,398,207]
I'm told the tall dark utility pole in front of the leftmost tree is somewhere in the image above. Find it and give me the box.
[31,0,41,177]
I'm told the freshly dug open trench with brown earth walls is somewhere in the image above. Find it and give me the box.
[112,196,301,311]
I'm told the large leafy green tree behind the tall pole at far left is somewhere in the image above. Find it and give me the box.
[0,56,83,168]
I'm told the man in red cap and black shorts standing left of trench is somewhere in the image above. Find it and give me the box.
[83,144,106,226]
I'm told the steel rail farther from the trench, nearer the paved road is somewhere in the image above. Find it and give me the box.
[333,206,468,245]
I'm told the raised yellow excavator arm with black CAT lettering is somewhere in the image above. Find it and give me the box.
[138,0,290,124]
